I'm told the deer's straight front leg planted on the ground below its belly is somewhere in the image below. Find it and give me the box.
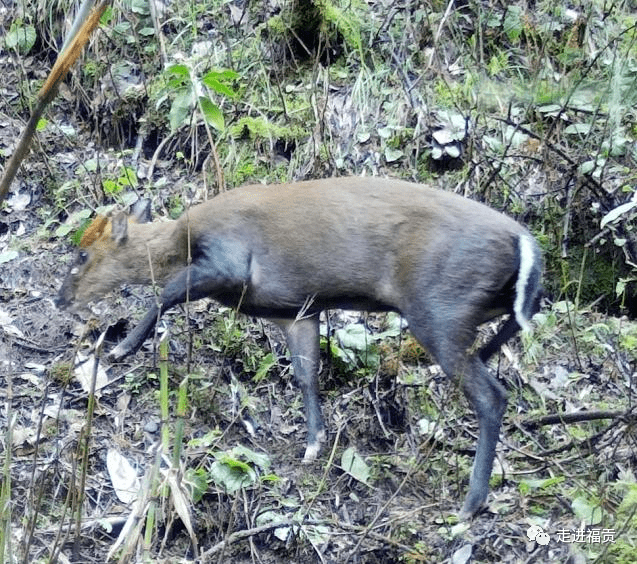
[275,313,325,462]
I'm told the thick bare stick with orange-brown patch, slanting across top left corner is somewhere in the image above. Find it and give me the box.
[0,0,109,207]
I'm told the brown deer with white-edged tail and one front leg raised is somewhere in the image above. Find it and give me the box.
[56,177,541,518]
